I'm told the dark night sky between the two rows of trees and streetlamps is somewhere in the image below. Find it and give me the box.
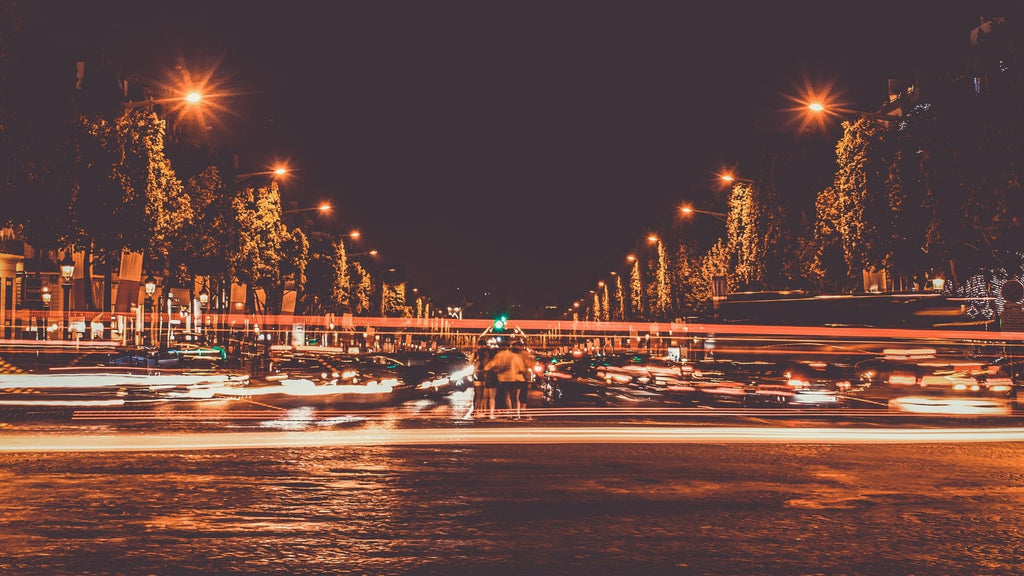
[29,0,986,313]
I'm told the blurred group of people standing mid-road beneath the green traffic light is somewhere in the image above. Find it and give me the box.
[473,336,534,418]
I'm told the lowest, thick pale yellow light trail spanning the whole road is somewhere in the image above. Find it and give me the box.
[0,425,1024,453]
